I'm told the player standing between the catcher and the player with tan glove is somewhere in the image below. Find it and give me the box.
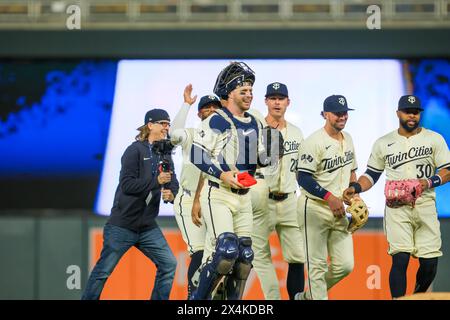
[250,82,305,300]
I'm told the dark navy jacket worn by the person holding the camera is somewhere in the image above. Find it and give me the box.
[108,141,179,232]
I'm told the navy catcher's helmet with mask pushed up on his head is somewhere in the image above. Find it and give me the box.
[214,62,255,100]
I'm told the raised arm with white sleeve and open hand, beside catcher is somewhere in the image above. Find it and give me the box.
[169,84,197,146]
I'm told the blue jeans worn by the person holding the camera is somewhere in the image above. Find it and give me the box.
[81,223,177,300]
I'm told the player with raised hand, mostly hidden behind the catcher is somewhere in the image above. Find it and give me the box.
[169,84,221,299]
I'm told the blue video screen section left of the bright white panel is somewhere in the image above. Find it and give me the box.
[0,61,117,178]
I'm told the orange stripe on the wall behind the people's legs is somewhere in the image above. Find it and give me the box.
[90,228,418,300]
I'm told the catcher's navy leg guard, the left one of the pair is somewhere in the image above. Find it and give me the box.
[191,232,239,300]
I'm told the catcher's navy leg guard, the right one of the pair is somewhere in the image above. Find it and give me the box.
[226,237,254,300]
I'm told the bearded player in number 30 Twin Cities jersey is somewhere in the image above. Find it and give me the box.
[344,95,450,298]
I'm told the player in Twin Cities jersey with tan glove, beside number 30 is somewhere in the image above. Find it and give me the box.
[296,95,357,300]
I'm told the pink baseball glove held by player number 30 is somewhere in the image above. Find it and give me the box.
[384,179,422,208]
